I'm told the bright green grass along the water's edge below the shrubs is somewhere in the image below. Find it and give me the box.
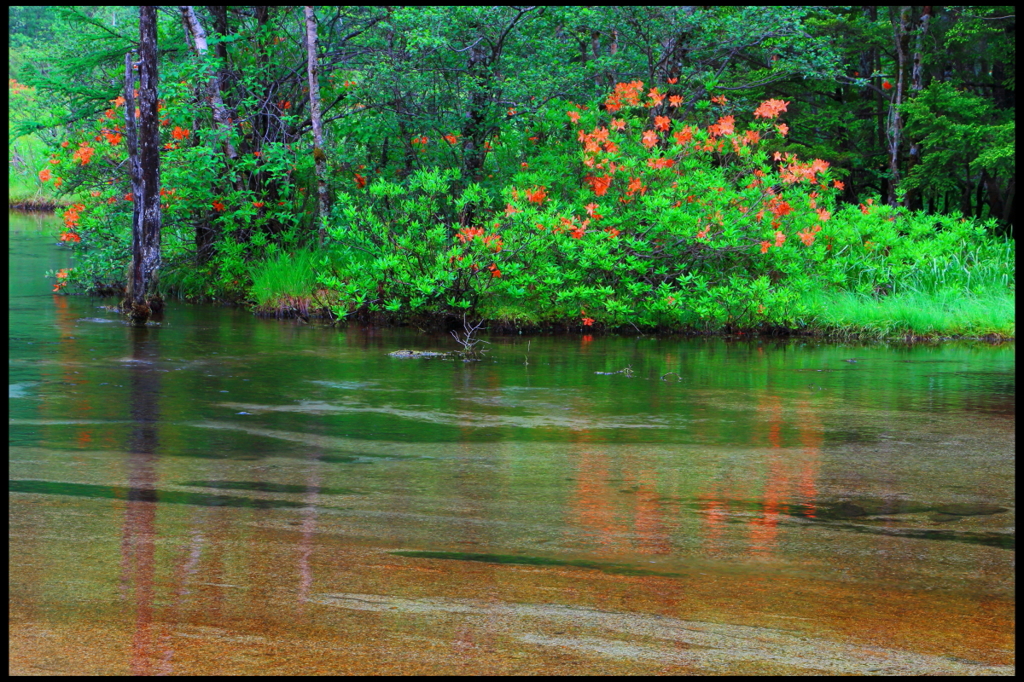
[234,236,1016,340]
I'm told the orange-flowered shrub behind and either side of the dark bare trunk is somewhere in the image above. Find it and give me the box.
[39,60,312,296]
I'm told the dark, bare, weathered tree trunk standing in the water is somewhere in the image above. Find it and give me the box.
[123,5,163,327]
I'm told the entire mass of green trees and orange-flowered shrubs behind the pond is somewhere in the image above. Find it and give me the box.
[18,6,1015,330]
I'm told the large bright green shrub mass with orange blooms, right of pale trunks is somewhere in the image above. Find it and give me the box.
[319,90,1014,336]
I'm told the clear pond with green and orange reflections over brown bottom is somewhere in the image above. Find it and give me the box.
[8,209,1016,675]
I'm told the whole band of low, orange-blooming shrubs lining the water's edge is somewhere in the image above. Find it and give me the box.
[25,65,1014,335]
